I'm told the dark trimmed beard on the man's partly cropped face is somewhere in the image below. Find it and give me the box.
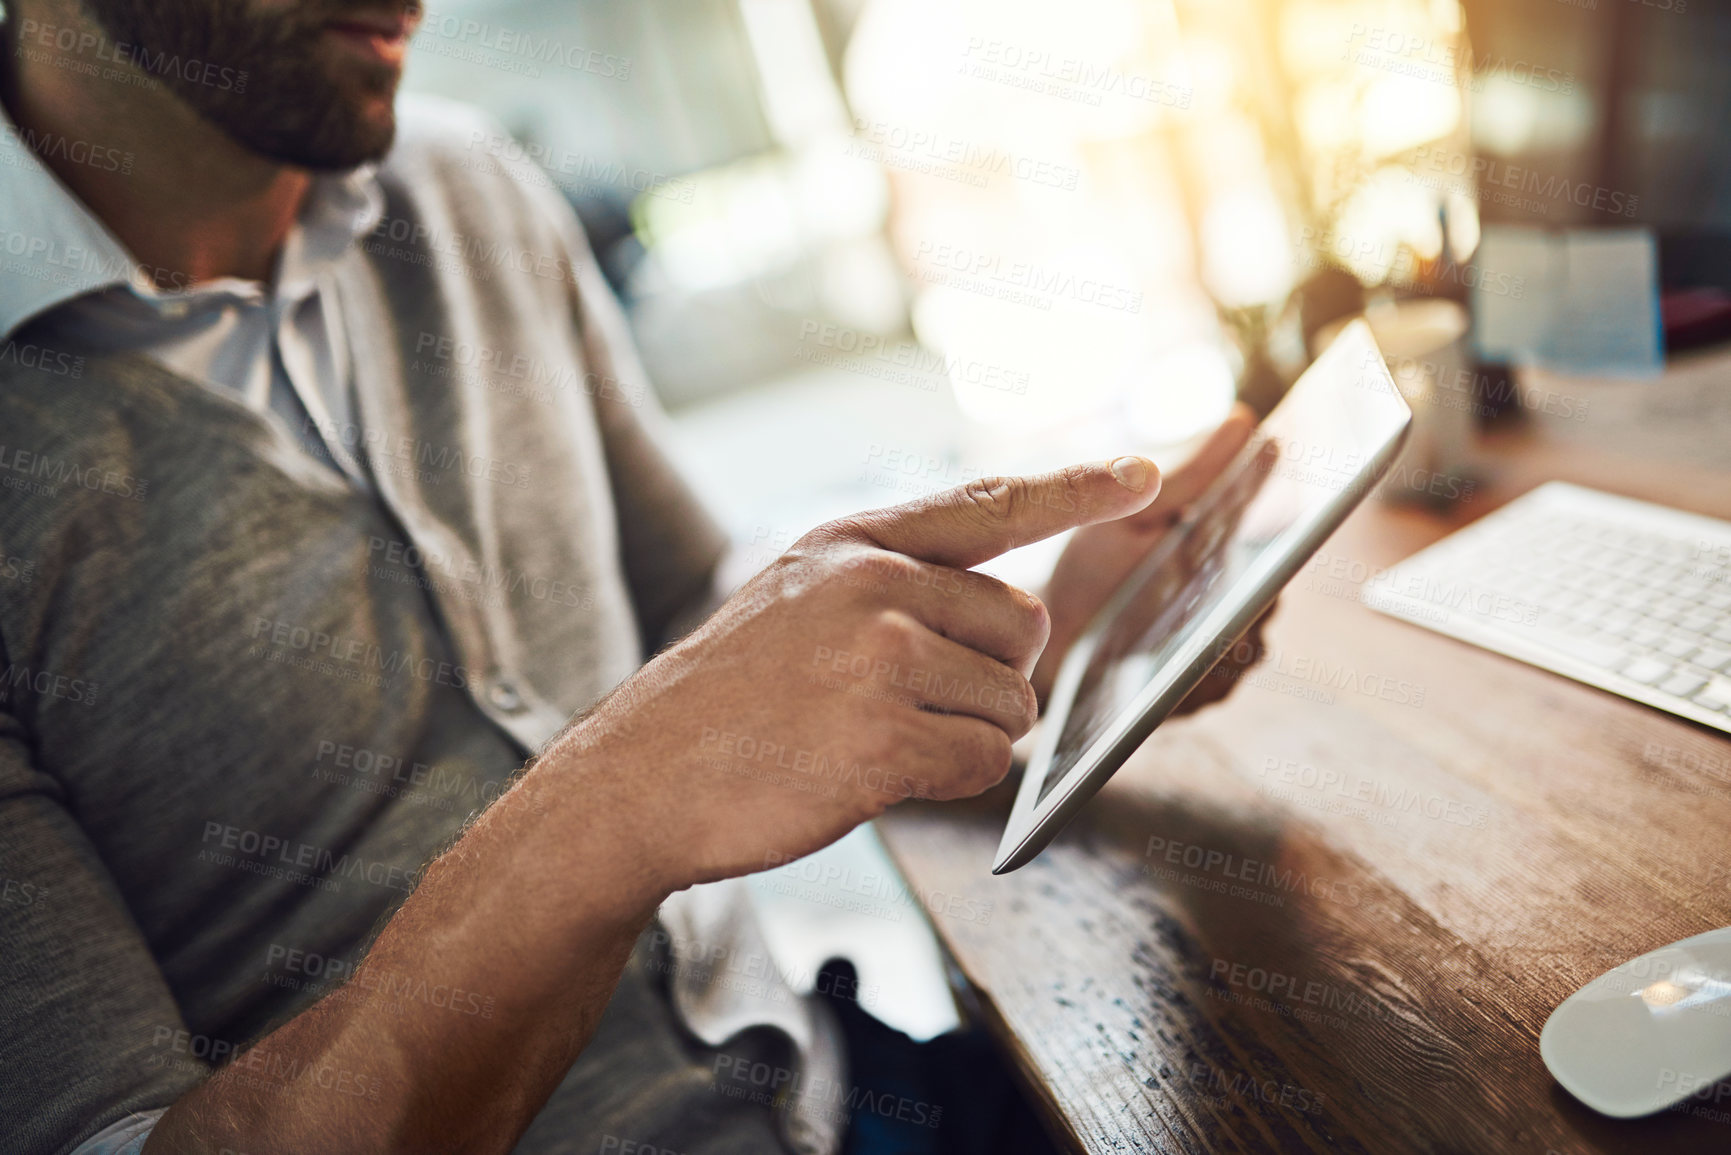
[83,0,419,170]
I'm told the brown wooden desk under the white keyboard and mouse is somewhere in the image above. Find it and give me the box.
[881,429,1731,1155]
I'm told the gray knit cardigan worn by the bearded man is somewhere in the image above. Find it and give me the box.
[0,96,823,1155]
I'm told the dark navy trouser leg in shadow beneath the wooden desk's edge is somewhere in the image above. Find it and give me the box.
[817,959,1056,1155]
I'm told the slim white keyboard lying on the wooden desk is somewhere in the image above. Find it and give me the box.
[1362,481,1731,734]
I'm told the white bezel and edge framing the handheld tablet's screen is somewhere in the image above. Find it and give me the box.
[992,320,1412,874]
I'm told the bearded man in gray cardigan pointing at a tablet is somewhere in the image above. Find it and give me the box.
[0,0,1246,1155]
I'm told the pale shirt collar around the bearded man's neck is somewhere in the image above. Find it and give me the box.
[0,95,384,341]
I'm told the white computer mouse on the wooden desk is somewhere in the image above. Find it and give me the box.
[1539,926,1731,1119]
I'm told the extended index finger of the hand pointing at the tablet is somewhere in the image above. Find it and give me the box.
[848,457,1160,570]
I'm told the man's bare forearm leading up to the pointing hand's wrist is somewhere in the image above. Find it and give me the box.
[145,748,668,1155]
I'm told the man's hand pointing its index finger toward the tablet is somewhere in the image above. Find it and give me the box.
[542,457,1160,890]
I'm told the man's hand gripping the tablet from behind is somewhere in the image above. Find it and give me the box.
[1032,403,1262,713]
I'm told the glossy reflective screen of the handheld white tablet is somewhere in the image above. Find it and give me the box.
[1035,329,1407,803]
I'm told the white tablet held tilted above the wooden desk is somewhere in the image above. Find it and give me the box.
[992,320,1412,874]
